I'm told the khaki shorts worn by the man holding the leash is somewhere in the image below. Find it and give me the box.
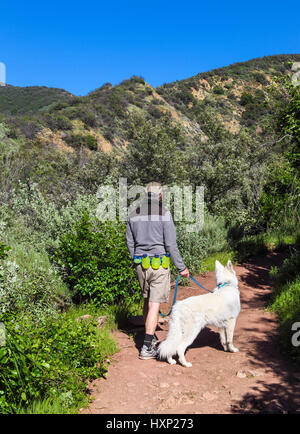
[136,264,171,303]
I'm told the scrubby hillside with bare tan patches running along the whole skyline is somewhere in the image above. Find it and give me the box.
[0,54,300,152]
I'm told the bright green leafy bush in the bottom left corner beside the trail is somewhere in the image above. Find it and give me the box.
[0,308,115,413]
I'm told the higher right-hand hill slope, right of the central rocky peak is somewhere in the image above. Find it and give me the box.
[157,55,300,134]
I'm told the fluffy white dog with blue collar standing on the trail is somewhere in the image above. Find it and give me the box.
[158,261,240,368]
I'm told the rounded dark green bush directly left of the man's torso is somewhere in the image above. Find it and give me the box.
[54,212,140,306]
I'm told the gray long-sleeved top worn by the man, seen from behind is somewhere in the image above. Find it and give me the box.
[126,193,186,272]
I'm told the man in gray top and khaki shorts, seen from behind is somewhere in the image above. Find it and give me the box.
[126,182,190,360]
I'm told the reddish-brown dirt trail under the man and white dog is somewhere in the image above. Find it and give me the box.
[81,253,300,414]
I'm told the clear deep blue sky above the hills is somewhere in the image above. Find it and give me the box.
[0,0,300,95]
